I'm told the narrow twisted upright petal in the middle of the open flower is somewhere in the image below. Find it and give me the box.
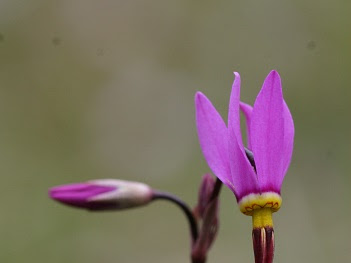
[228,72,259,201]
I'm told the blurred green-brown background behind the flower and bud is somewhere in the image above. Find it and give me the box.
[0,0,351,263]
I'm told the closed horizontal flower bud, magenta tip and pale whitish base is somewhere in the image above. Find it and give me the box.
[49,179,152,210]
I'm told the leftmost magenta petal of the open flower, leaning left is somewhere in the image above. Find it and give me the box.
[195,92,233,190]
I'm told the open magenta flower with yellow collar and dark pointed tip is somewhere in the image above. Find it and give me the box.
[195,71,294,263]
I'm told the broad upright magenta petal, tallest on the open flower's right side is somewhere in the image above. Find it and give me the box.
[250,71,285,193]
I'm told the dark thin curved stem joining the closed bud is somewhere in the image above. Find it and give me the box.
[152,191,199,242]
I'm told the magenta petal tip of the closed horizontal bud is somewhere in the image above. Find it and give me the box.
[49,183,116,208]
